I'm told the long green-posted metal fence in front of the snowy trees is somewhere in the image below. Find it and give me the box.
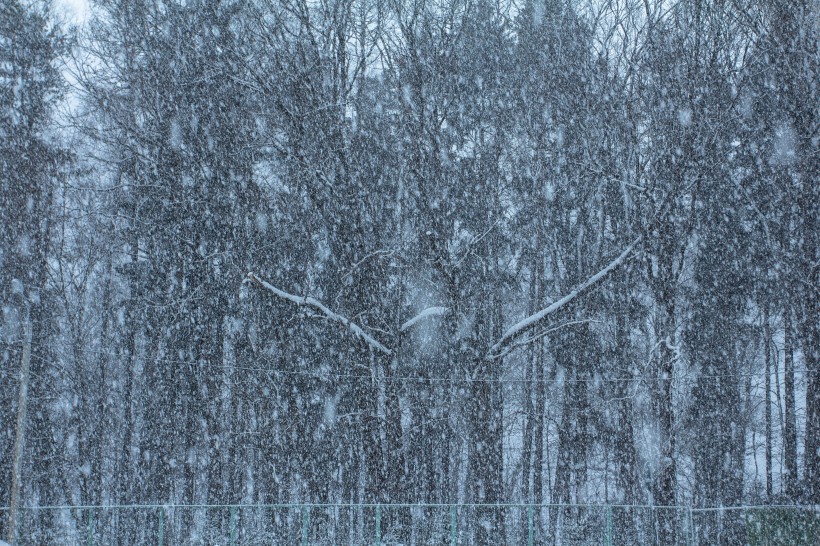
[0,504,820,546]
